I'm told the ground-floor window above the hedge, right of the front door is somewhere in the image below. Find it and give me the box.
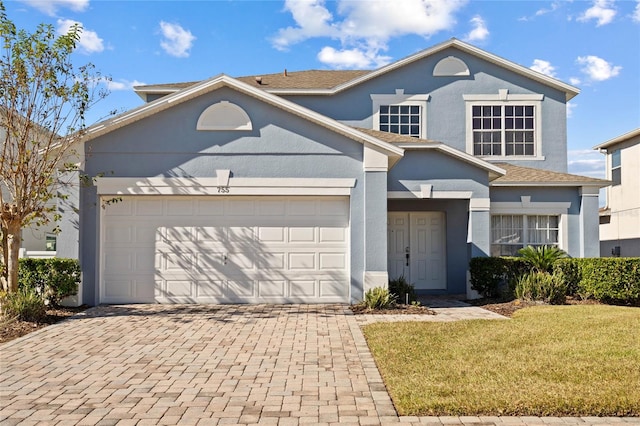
[491,214,560,256]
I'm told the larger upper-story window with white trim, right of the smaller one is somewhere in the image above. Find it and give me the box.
[464,90,544,159]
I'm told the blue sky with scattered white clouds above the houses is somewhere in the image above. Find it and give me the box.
[5,0,640,177]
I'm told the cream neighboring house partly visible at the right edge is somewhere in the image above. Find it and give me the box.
[594,128,640,257]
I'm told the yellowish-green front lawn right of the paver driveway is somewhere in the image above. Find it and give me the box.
[363,305,640,416]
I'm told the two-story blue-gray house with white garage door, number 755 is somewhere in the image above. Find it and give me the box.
[58,39,606,304]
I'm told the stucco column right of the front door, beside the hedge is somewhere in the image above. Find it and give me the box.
[467,198,491,299]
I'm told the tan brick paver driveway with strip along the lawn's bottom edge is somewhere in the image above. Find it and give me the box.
[0,305,640,426]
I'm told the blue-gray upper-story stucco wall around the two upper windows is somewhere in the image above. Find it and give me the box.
[288,48,567,172]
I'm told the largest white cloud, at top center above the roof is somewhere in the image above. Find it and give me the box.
[271,0,467,68]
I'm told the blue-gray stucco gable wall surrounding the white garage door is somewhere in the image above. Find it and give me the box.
[81,89,372,304]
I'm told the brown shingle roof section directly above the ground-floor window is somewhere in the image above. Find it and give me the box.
[491,163,610,187]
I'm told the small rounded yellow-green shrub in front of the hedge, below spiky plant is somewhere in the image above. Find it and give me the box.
[514,271,567,305]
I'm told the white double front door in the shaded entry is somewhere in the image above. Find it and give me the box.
[387,212,447,290]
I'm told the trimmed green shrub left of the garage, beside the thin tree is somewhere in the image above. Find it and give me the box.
[18,258,80,305]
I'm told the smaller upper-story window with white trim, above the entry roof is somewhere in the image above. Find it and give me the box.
[371,89,429,139]
